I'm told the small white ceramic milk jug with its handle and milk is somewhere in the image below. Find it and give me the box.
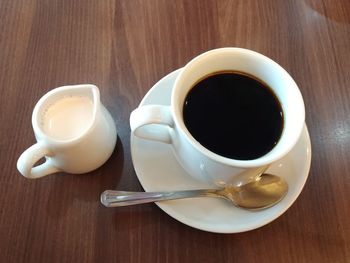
[17,84,117,179]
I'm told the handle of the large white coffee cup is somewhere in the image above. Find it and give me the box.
[130,105,174,144]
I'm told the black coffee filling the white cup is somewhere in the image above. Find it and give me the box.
[183,71,283,160]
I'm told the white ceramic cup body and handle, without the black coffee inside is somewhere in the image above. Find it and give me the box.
[130,48,305,188]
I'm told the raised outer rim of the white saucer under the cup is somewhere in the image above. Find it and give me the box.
[130,68,312,234]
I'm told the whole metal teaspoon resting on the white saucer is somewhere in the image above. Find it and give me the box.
[101,174,288,210]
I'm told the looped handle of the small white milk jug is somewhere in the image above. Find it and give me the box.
[17,142,60,179]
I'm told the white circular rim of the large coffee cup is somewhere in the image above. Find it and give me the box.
[170,47,305,168]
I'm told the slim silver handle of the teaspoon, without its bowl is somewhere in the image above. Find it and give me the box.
[101,189,217,207]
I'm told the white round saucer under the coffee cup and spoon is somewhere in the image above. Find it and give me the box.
[131,70,311,233]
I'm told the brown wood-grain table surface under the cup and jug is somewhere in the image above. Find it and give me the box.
[0,0,350,262]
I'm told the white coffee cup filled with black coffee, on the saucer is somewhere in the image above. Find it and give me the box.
[130,48,305,186]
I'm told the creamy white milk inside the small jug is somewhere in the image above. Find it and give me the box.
[41,96,94,140]
